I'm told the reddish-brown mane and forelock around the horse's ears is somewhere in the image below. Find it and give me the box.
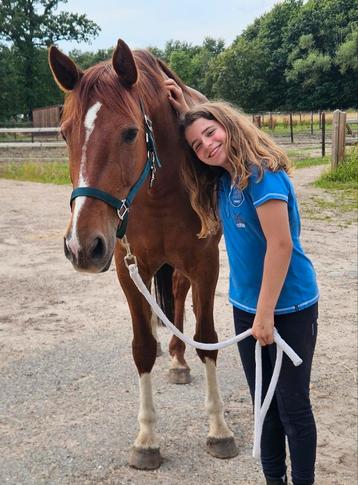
[62,50,187,130]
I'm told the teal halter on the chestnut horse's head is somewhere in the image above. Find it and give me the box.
[70,103,162,239]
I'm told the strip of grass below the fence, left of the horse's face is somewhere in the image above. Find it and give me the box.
[0,162,70,185]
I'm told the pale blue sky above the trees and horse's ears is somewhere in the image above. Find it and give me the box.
[56,0,279,53]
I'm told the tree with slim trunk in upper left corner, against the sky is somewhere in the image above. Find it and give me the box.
[0,0,100,116]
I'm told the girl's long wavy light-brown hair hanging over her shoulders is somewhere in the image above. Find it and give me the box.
[182,101,292,238]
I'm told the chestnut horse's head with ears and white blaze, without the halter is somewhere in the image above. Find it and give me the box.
[49,40,164,272]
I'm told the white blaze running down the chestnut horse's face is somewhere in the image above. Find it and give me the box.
[68,101,102,255]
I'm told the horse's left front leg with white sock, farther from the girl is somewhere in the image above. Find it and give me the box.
[116,253,162,470]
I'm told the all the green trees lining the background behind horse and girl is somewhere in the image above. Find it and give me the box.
[0,0,358,120]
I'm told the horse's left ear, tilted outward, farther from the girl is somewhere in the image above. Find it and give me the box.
[48,45,83,91]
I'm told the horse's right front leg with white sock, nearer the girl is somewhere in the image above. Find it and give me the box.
[192,272,238,458]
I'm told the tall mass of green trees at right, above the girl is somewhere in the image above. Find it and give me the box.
[212,0,358,112]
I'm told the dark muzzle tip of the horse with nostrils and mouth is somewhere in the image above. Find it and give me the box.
[64,235,113,273]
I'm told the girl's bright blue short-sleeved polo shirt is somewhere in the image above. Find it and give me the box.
[218,170,319,314]
